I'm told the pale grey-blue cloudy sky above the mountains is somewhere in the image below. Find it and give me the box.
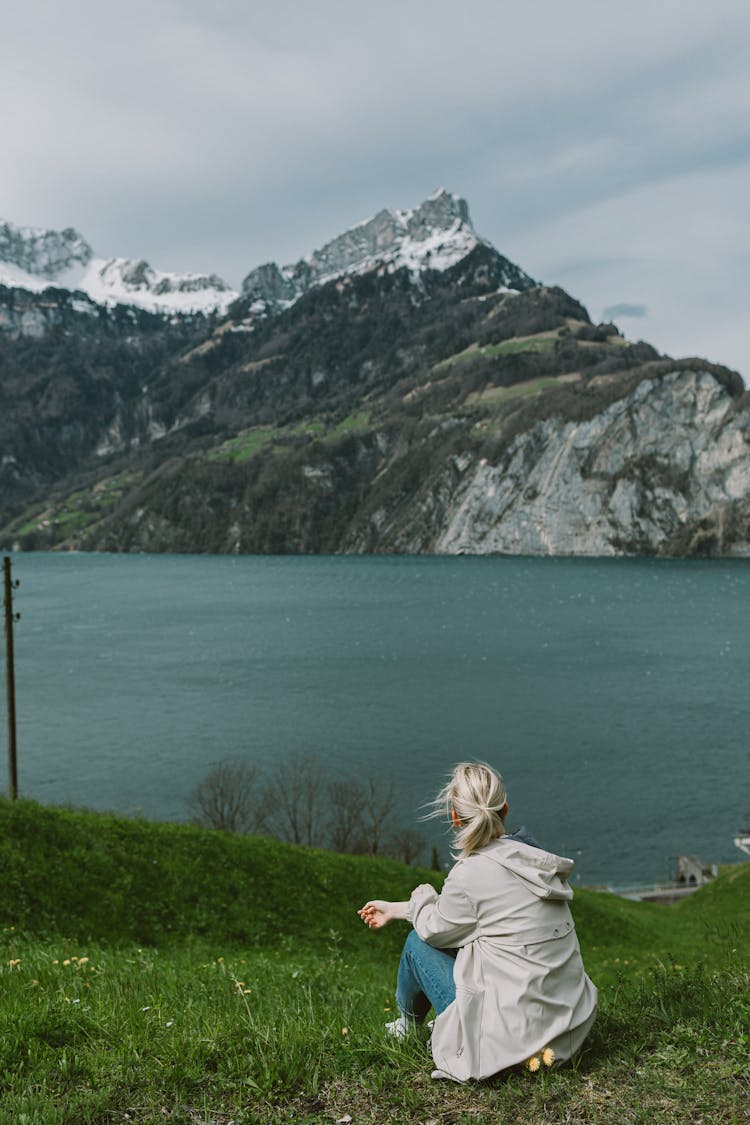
[0,0,750,384]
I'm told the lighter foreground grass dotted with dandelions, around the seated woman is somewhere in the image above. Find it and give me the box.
[0,933,750,1123]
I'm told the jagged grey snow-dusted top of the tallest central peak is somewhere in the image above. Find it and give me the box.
[242,188,489,308]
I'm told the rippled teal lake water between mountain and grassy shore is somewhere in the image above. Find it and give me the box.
[0,555,750,883]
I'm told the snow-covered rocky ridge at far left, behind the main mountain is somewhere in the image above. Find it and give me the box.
[0,222,237,314]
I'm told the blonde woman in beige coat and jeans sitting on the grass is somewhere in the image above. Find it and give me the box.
[358,762,597,1081]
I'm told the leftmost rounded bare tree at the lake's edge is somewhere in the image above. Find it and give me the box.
[188,761,265,833]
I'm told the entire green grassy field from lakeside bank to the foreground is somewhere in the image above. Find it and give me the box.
[0,801,750,1125]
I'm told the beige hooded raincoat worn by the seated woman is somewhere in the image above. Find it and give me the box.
[407,837,597,1081]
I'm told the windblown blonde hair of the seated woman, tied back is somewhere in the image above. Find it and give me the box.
[428,762,507,858]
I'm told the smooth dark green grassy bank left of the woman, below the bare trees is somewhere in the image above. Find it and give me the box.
[0,801,434,948]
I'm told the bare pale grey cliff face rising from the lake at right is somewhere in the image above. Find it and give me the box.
[432,371,750,556]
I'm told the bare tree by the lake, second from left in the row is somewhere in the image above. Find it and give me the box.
[264,754,327,846]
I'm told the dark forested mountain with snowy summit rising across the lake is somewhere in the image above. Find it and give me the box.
[0,198,750,555]
